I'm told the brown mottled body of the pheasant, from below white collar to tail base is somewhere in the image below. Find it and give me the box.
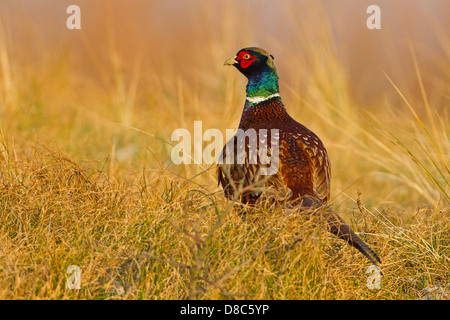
[217,98,331,203]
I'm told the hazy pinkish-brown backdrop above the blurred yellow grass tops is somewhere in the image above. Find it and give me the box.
[0,0,450,107]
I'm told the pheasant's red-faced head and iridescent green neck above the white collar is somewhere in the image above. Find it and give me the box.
[225,47,279,99]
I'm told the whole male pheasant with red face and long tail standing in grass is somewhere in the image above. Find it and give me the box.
[217,47,381,264]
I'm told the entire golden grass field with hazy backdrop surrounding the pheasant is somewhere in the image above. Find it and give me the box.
[0,0,450,299]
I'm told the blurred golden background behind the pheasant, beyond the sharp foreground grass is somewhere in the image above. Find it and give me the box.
[0,0,450,206]
